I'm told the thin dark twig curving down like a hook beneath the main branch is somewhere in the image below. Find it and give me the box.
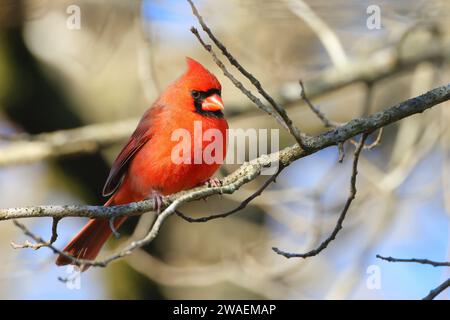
[272,133,368,258]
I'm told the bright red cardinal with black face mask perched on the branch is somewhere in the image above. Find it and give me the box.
[56,58,228,271]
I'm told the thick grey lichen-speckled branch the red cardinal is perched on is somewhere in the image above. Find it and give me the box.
[0,84,450,225]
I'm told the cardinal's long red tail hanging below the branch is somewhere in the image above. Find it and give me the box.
[56,199,127,271]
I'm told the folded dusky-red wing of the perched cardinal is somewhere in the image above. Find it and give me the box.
[103,105,163,197]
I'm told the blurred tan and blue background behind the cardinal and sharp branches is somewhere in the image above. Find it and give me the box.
[0,0,450,299]
